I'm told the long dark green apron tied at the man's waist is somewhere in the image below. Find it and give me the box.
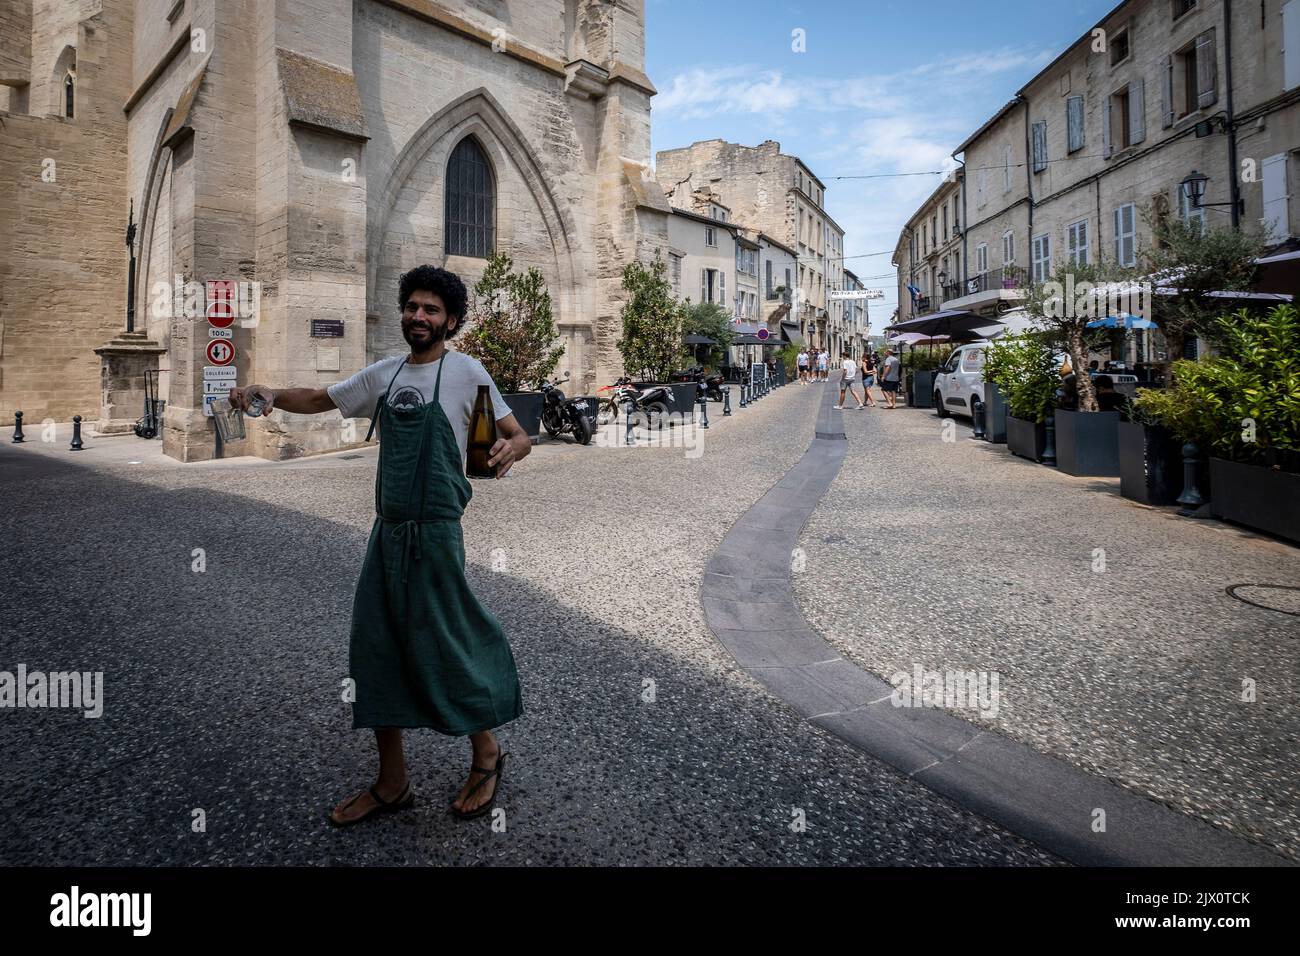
[350,359,523,736]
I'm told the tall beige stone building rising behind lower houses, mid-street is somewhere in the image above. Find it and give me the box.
[655,139,844,349]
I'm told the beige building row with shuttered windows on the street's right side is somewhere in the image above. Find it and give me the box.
[896,0,1300,343]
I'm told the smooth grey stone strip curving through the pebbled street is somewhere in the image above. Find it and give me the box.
[701,388,1294,866]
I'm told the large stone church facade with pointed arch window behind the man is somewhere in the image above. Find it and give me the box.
[0,0,668,460]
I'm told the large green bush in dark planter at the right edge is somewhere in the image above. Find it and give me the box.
[1136,306,1300,541]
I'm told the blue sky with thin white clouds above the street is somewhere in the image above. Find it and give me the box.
[646,0,1118,321]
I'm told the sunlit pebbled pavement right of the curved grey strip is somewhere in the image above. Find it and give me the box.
[794,408,1300,857]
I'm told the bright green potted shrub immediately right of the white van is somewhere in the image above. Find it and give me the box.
[985,332,1061,462]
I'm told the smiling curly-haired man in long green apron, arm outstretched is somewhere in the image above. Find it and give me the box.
[230,265,532,826]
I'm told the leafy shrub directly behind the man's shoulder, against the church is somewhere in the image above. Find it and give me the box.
[460,252,564,442]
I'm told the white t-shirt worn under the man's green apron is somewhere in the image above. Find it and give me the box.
[326,349,511,457]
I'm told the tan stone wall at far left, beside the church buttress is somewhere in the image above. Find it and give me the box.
[0,0,131,421]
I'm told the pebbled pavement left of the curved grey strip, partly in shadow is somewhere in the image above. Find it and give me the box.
[0,386,1057,865]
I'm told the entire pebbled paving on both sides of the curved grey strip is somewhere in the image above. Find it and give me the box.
[0,385,1300,865]
